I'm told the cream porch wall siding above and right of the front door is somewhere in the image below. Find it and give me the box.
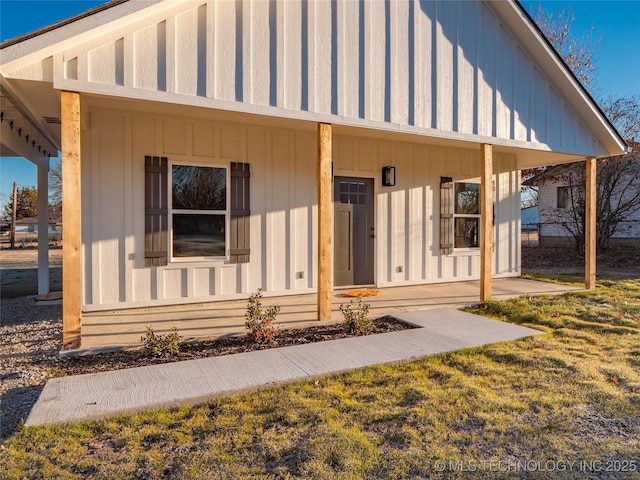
[334,136,520,287]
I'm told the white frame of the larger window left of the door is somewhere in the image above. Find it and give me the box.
[167,160,231,263]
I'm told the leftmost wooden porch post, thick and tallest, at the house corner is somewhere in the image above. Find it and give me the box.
[60,91,82,348]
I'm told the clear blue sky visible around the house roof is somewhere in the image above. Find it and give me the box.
[0,0,640,203]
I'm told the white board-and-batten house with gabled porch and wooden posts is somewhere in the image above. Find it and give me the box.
[0,0,625,347]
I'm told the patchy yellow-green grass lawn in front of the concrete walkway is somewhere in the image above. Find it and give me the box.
[0,279,640,479]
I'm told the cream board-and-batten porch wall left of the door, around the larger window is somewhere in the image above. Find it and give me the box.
[82,109,317,311]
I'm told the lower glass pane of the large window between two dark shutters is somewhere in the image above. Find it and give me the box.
[173,213,226,257]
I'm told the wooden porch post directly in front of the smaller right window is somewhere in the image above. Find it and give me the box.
[480,143,493,302]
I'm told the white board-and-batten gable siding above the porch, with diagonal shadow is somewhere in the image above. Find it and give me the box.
[6,0,603,156]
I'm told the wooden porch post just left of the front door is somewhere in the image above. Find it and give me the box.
[318,123,333,320]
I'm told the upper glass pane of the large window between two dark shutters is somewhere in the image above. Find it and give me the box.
[171,165,227,210]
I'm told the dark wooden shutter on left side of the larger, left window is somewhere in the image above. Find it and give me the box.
[144,156,169,267]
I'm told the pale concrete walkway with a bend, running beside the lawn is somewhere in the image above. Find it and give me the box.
[26,308,541,425]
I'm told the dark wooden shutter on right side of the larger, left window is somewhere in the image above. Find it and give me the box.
[229,162,251,263]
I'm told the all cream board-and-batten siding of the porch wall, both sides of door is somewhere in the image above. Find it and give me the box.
[82,107,520,311]
